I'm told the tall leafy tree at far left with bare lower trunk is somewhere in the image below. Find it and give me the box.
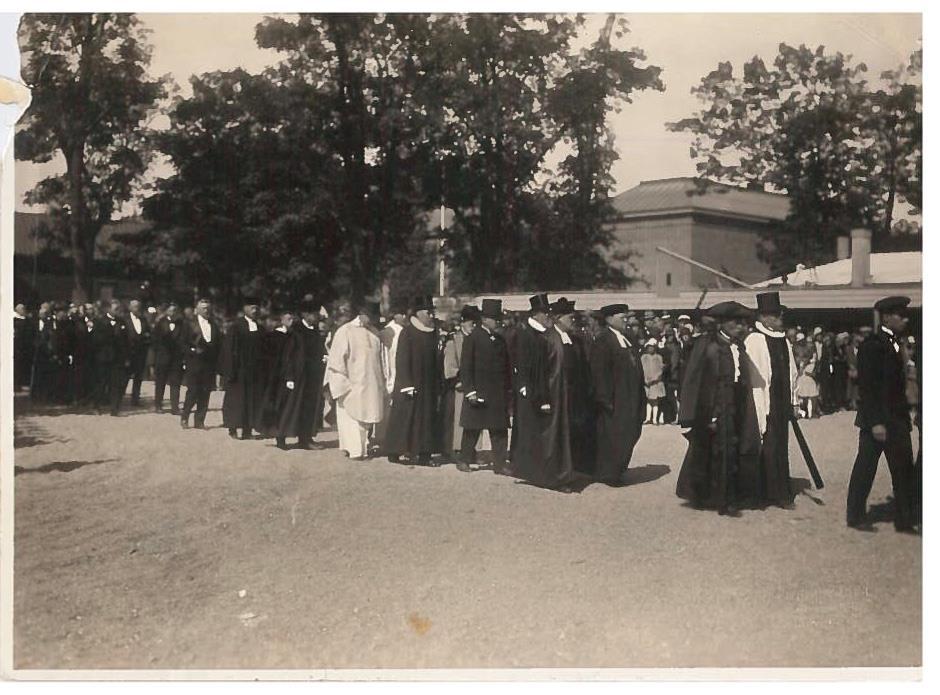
[15,13,166,299]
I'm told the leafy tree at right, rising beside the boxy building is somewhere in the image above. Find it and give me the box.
[669,44,919,264]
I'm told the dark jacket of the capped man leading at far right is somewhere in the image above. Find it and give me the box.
[855,327,911,430]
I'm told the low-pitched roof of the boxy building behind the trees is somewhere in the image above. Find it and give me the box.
[613,176,790,222]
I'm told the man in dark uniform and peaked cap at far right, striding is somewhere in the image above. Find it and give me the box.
[846,297,914,532]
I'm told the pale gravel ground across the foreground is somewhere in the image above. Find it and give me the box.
[14,385,921,669]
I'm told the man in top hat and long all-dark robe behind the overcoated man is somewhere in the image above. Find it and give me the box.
[510,294,574,492]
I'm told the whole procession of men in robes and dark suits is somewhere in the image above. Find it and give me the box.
[7,292,919,531]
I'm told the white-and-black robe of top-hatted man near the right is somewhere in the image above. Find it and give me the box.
[744,322,797,505]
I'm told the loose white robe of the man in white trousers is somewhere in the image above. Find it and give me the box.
[326,318,388,426]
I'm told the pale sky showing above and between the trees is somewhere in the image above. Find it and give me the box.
[15,13,922,215]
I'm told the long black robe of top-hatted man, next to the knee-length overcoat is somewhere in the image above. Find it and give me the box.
[513,326,574,488]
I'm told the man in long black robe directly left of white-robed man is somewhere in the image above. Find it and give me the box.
[277,299,326,449]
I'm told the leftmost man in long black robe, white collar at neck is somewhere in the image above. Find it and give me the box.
[222,298,264,439]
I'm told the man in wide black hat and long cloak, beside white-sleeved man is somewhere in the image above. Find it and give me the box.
[676,302,760,516]
